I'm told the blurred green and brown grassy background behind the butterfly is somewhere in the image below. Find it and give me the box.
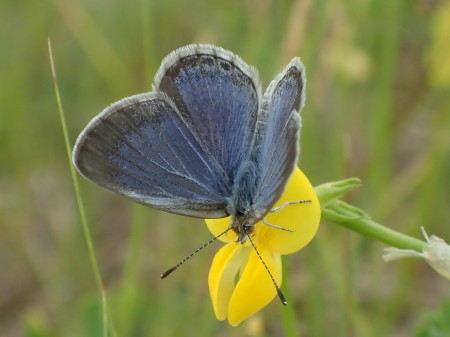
[0,0,450,337]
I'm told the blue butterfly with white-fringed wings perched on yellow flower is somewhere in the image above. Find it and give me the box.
[73,44,306,243]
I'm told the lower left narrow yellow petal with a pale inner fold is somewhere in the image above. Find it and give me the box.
[208,242,248,321]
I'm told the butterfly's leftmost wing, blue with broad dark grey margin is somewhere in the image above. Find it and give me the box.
[73,93,230,218]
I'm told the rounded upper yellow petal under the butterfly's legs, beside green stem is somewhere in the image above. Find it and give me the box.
[255,168,321,255]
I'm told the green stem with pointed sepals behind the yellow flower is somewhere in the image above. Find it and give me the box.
[315,178,427,252]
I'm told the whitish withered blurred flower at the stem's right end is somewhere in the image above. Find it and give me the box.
[383,227,450,280]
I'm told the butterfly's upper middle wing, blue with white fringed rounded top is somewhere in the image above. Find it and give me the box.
[154,45,260,180]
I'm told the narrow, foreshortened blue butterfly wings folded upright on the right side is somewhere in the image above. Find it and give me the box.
[252,58,306,217]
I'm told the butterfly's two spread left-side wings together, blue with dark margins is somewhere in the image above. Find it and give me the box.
[73,45,258,218]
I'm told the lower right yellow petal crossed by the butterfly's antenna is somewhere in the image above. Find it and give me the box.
[228,243,282,326]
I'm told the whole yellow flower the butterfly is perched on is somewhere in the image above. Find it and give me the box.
[206,168,320,326]
